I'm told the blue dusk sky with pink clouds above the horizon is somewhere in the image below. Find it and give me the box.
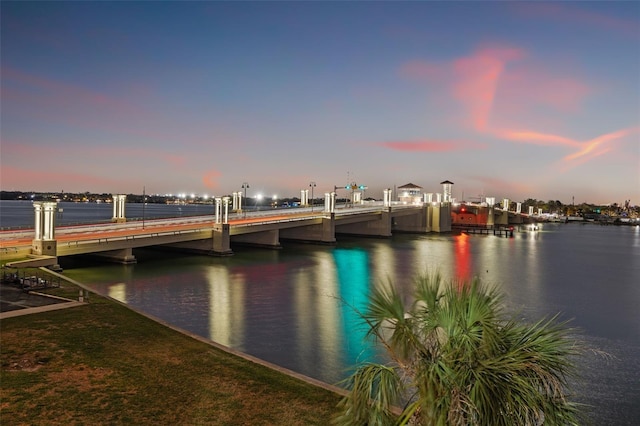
[0,1,640,205]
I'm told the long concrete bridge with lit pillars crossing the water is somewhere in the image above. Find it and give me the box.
[0,196,451,266]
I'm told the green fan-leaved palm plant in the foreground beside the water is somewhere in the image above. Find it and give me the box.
[334,274,578,426]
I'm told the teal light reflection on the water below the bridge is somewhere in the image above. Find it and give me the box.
[333,248,373,362]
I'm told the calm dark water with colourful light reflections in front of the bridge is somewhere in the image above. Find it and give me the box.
[2,201,640,425]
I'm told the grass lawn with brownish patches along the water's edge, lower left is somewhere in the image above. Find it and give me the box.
[0,283,340,425]
